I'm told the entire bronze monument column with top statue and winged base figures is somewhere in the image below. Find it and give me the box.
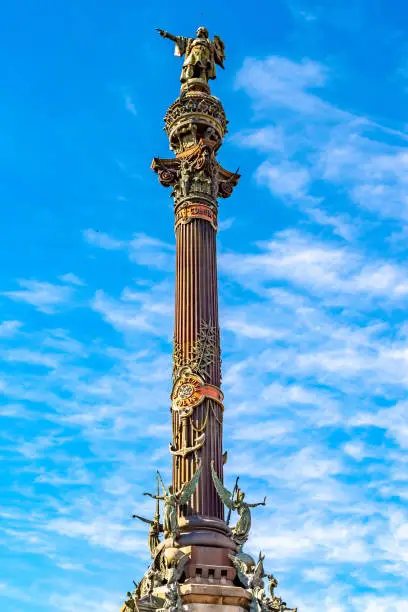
[121,27,296,612]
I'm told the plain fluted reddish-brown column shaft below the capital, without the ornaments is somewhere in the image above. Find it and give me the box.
[172,219,224,519]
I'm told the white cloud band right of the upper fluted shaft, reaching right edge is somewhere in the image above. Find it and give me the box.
[220,230,408,300]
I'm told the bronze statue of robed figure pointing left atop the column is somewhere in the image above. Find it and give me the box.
[157,26,225,84]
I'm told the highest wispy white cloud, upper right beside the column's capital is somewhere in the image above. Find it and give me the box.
[233,56,408,227]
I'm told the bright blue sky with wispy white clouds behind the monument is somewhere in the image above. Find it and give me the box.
[0,0,408,612]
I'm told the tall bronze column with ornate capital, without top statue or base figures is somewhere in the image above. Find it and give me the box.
[152,63,239,519]
